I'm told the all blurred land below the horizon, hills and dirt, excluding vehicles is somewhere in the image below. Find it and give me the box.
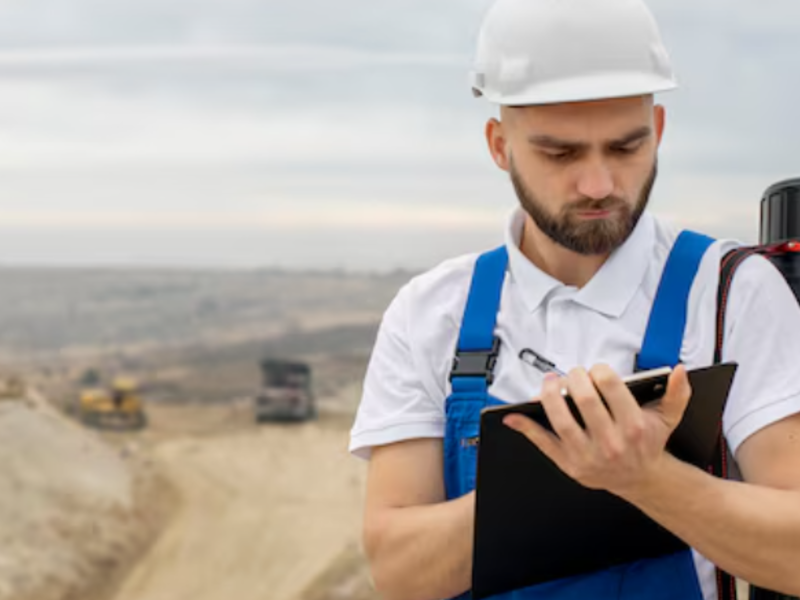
[0,269,411,600]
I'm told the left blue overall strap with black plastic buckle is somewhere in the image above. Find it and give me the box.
[450,246,508,392]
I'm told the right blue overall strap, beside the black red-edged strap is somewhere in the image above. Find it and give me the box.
[636,231,714,371]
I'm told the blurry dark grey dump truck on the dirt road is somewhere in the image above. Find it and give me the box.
[255,359,317,422]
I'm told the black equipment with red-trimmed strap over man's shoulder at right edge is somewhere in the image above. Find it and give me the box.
[714,179,800,600]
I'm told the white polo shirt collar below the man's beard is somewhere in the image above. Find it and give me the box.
[506,208,655,318]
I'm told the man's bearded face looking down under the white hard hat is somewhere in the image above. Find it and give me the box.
[490,98,663,255]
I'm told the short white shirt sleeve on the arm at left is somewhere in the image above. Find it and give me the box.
[350,286,445,459]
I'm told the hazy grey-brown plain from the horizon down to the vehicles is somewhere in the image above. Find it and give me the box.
[0,269,412,403]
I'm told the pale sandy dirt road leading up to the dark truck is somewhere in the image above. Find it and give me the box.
[109,412,364,600]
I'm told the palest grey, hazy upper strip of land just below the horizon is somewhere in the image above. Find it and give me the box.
[0,269,410,353]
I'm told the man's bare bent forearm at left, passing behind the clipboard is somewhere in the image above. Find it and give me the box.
[365,493,475,600]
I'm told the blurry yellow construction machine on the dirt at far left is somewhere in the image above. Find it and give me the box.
[79,377,147,429]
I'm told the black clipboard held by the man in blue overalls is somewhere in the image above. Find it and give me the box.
[472,363,736,600]
